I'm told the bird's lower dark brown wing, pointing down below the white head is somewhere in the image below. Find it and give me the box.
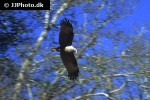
[60,51,79,80]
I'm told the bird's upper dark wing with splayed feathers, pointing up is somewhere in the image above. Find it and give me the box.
[59,18,74,48]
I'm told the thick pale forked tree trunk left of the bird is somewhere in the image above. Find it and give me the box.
[12,2,69,100]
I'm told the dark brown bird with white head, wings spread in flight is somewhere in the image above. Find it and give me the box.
[51,18,79,80]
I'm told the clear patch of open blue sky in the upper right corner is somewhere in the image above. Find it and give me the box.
[118,0,150,29]
